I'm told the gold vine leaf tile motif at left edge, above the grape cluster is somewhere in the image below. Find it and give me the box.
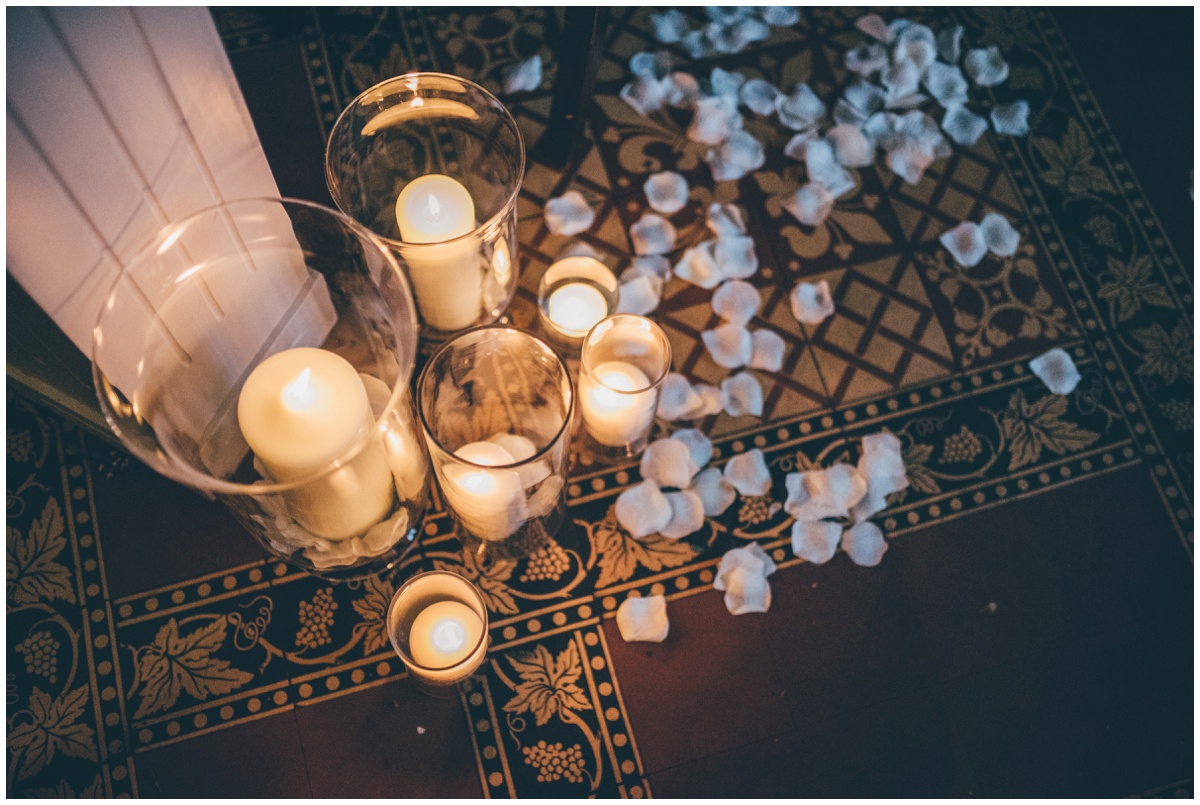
[5,498,76,603]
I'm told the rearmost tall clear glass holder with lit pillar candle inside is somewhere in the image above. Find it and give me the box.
[325,72,524,343]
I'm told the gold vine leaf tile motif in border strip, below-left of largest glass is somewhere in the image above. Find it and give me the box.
[133,615,254,719]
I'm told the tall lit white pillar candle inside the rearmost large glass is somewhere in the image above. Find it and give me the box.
[396,174,484,332]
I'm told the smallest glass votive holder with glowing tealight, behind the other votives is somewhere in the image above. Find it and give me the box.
[538,254,619,356]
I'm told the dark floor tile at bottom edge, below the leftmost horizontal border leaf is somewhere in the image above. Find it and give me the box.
[134,711,314,799]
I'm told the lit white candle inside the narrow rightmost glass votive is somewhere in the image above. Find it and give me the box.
[580,361,654,447]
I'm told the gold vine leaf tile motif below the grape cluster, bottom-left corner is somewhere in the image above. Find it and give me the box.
[8,685,100,780]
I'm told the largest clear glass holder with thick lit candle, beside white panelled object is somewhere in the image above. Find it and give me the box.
[92,199,430,579]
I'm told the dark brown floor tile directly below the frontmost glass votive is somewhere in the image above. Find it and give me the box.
[296,679,481,799]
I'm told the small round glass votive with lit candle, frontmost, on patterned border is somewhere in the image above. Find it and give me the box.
[388,570,487,696]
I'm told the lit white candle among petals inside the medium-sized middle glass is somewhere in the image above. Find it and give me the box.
[442,441,529,541]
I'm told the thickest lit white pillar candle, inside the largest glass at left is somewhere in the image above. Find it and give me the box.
[238,347,392,540]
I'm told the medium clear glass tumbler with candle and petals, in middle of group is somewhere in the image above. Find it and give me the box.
[416,326,575,559]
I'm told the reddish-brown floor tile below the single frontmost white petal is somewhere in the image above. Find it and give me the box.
[605,591,791,774]
